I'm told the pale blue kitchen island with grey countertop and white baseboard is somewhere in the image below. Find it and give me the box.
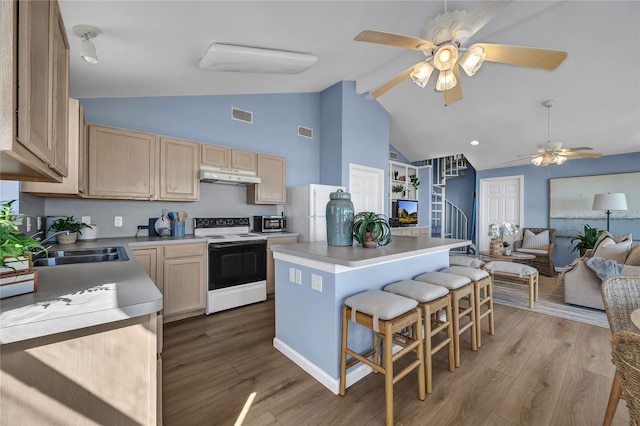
[273,236,470,395]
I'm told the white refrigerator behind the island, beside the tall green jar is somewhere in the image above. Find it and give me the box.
[284,184,345,242]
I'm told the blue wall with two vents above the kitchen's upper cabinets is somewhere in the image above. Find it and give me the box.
[80,93,322,186]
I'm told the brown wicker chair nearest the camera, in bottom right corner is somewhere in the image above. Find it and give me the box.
[611,331,640,426]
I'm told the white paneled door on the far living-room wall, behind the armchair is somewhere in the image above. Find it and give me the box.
[477,176,524,251]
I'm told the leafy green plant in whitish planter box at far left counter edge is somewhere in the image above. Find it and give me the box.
[0,200,46,298]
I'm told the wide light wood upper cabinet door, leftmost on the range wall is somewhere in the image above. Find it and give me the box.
[88,125,158,199]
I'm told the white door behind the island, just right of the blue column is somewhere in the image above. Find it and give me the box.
[349,163,384,214]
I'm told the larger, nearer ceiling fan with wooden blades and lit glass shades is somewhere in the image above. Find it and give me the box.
[355,0,567,105]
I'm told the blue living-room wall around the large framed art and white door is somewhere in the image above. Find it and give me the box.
[477,152,640,267]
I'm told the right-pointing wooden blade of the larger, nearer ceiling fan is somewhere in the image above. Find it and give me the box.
[472,43,567,70]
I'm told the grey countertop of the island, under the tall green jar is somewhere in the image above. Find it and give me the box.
[273,235,470,267]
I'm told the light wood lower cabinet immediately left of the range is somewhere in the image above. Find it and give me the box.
[132,241,206,322]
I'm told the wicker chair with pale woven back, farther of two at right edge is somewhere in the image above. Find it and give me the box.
[600,276,640,425]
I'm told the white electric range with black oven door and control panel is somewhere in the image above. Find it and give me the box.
[193,217,267,315]
